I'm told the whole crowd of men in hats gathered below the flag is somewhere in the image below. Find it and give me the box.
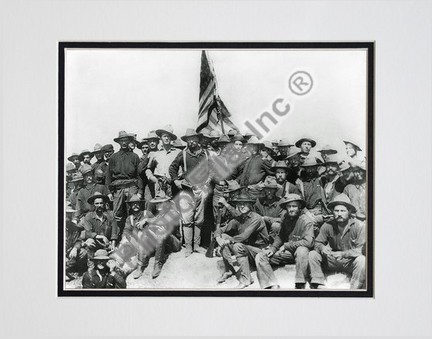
[65,125,367,289]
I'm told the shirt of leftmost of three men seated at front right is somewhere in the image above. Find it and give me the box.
[215,212,269,248]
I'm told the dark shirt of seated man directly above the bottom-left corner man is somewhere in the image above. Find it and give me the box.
[83,211,119,240]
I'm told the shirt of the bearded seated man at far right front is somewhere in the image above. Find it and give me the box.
[315,218,366,258]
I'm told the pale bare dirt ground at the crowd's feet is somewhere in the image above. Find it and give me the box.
[66,249,350,290]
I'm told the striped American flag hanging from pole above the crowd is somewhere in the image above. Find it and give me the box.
[197,51,238,134]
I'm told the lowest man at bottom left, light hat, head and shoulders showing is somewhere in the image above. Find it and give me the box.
[82,249,126,288]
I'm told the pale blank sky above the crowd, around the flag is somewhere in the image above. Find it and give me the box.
[65,49,367,157]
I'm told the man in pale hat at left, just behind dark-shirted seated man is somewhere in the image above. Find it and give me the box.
[74,164,109,223]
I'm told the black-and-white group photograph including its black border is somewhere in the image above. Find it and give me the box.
[58,42,374,297]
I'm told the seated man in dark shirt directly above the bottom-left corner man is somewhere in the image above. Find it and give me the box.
[82,192,119,258]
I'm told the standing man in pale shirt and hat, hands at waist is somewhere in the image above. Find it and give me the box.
[145,125,181,197]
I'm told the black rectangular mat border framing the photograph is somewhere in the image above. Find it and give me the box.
[57,42,375,298]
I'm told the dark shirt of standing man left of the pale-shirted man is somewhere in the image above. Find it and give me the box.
[105,149,143,195]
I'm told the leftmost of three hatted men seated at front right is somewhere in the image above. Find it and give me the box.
[215,193,269,288]
